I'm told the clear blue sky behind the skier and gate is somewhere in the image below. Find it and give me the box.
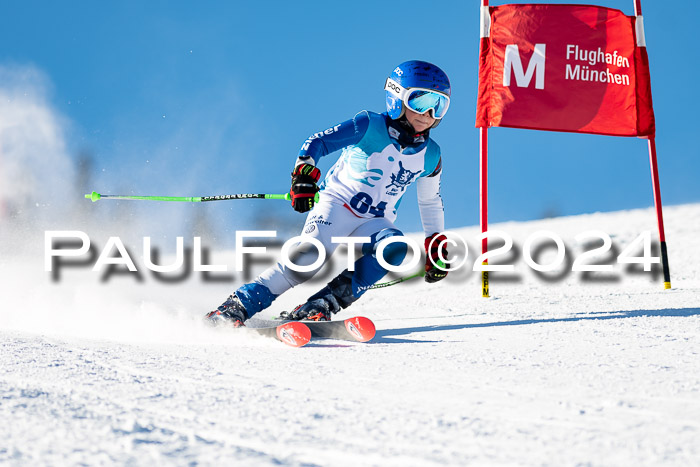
[0,0,700,238]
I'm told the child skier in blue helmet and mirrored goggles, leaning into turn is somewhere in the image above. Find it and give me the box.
[206,60,450,326]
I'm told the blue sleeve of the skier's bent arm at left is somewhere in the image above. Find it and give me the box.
[295,110,369,166]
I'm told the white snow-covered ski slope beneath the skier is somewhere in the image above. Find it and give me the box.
[0,205,700,466]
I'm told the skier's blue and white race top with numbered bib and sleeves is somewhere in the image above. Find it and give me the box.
[297,110,445,236]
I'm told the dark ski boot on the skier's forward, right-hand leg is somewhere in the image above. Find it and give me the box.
[280,269,358,321]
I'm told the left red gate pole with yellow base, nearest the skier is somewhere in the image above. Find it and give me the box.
[479,0,491,297]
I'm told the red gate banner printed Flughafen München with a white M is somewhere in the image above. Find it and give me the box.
[476,4,655,137]
